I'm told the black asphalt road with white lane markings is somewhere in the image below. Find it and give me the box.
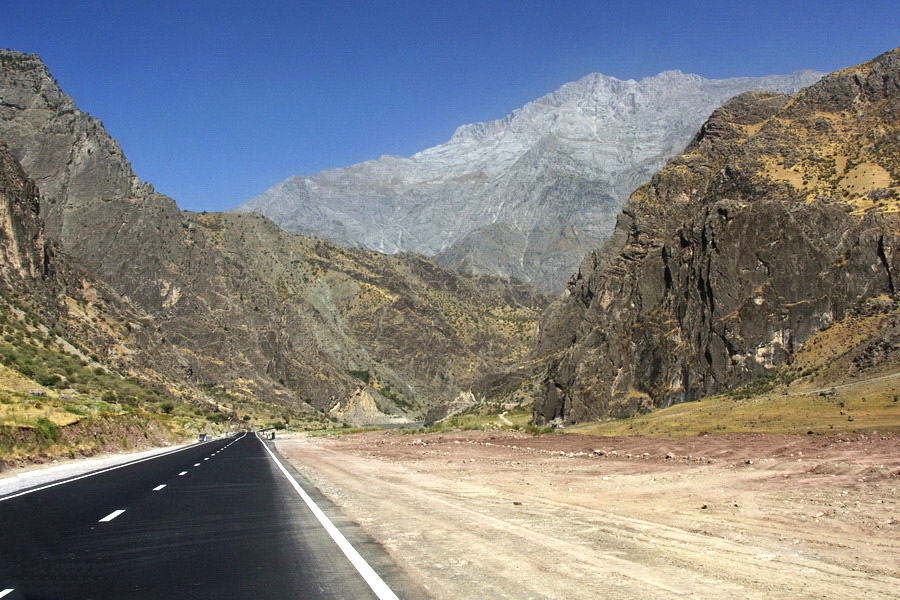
[0,434,402,600]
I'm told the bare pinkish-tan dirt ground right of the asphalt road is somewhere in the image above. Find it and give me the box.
[277,430,900,599]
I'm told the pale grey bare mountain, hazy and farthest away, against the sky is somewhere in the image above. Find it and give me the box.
[237,71,822,293]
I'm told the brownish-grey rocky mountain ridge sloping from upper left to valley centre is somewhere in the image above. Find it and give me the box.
[0,51,546,426]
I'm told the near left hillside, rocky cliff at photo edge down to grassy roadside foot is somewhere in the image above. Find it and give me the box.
[0,143,246,464]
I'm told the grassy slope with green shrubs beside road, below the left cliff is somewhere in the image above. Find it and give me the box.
[0,290,239,463]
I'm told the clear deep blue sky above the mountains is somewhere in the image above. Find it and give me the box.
[0,0,900,210]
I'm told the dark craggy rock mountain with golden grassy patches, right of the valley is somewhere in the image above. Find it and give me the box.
[535,51,900,422]
